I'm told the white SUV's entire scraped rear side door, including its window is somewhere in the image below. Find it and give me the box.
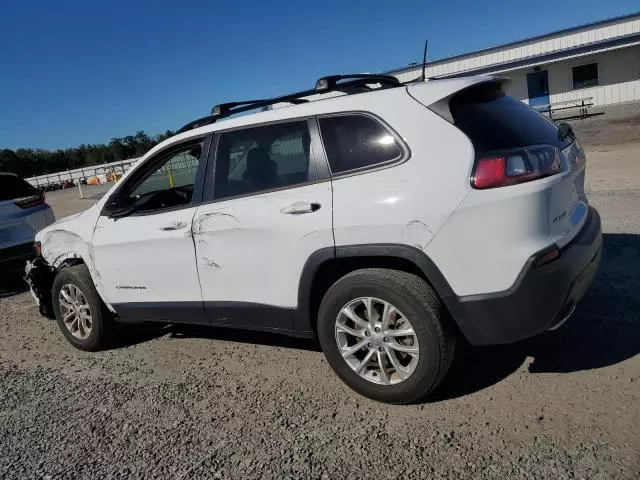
[193,120,334,329]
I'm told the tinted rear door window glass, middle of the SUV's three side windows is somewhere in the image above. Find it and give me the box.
[214,121,311,199]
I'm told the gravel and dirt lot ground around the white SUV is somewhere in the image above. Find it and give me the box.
[0,111,640,480]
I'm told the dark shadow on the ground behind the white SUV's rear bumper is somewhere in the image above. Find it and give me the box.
[429,234,640,402]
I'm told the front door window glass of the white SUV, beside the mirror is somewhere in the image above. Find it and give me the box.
[128,141,204,212]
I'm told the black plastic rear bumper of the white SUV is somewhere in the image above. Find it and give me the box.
[447,207,602,345]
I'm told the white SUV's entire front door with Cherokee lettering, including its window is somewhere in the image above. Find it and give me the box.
[93,139,206,322]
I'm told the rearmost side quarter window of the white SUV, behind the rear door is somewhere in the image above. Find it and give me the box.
[319,115,402,174]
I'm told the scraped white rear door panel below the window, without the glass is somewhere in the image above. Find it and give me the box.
[193,180,334,329]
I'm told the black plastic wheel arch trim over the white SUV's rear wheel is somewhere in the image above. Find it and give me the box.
[294,244,457,337]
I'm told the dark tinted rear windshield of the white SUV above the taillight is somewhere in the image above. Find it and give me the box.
[449,83,571,152]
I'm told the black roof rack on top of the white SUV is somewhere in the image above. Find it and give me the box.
[176,73,402,133]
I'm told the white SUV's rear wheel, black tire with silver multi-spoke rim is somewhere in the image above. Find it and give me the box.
[318,268,455,404]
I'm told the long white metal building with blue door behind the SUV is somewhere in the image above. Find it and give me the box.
[387,12,640,108]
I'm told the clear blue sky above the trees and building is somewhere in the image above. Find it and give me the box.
[0,0,639,149]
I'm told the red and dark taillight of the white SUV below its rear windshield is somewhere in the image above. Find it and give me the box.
[471,145,567,189]
